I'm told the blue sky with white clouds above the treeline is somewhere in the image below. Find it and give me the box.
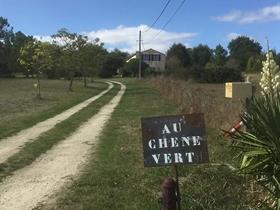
[0,0,280,53]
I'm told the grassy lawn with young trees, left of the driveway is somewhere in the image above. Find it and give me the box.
[0,79,107,139]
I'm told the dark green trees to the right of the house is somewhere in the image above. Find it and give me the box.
[165,36,280,82]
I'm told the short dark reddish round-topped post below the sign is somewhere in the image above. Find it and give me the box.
[161,178,177,210]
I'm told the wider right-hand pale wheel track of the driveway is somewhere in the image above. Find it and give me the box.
[0,81,126,210]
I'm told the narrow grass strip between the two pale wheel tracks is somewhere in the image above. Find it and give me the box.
[0,85,120,181]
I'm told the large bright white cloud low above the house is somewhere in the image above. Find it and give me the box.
[83,25,197,53]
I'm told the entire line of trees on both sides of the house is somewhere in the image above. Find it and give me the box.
[0,17,280,83]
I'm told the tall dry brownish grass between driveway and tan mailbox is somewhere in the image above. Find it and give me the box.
[152,77,245,130]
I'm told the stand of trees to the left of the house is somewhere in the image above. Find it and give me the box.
[0,17,128,83]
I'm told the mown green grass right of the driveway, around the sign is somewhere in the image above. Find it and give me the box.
[41,80,260,210]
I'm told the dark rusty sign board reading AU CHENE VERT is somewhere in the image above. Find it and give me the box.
[141,114,209,167]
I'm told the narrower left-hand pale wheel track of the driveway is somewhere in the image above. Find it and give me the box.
[0,82,113,163]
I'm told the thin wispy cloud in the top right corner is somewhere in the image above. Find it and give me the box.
[214,4,280,24]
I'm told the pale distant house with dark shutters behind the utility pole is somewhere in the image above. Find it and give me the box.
[126,49,166,72]
